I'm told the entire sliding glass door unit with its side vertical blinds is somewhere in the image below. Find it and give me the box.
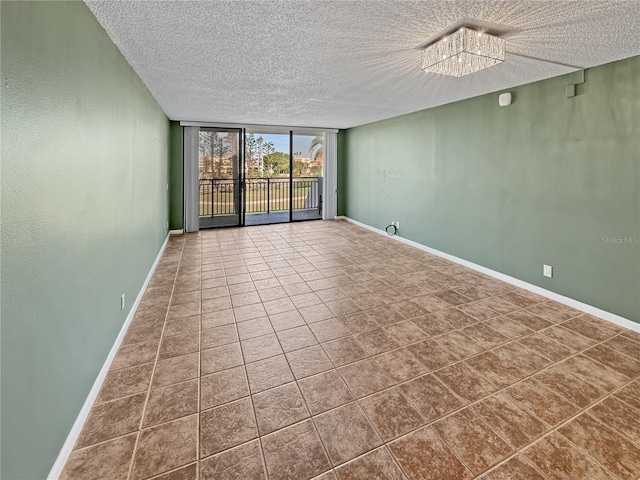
[183,122,336,232]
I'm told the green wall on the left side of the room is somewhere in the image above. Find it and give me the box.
[1,1,169,480]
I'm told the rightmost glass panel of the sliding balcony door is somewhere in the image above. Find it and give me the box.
[293,131,324,220]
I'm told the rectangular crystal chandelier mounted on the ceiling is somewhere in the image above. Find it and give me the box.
[422,27,506,77]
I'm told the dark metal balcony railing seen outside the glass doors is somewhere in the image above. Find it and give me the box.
[199,177,322,217]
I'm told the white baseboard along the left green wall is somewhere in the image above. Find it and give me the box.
[47,231,169,480]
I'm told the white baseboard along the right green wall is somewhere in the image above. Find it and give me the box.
[336,216,640,333]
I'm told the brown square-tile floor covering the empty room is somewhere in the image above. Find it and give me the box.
[62,221,640,480]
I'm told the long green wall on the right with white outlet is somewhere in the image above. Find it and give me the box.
[338,57,640,322]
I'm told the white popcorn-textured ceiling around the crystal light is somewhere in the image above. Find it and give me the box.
[86,0,640,128]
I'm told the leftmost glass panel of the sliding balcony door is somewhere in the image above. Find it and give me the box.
[199,128,241,228]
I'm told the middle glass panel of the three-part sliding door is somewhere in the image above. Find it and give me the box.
[245,131,289,225]
